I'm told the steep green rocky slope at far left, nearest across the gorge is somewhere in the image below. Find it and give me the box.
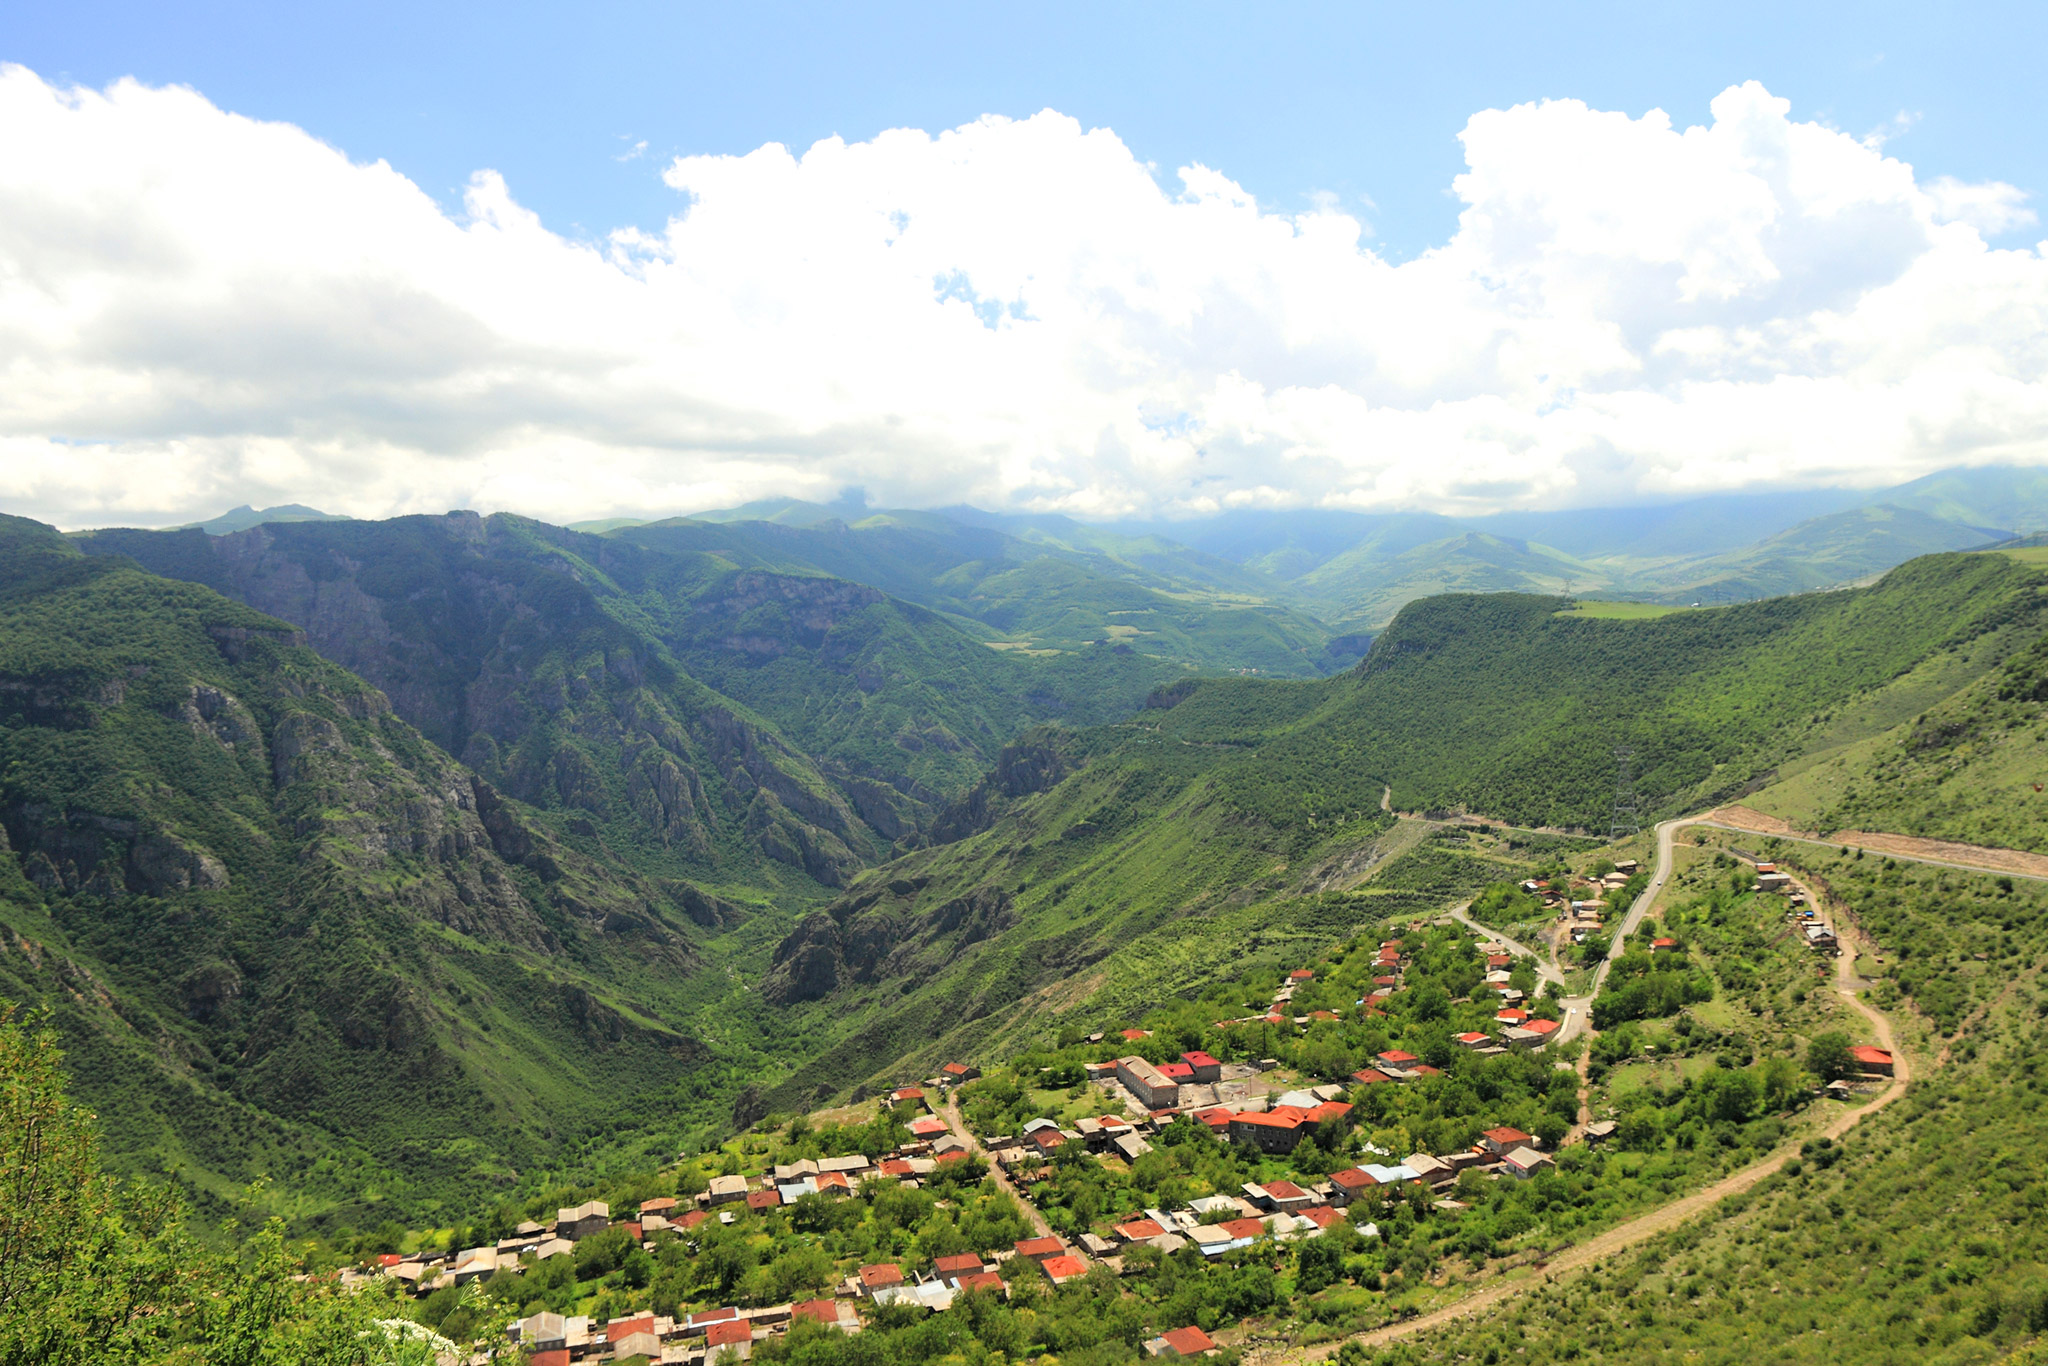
[0,518,790,1223]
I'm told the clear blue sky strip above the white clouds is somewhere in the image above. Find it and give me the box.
[16,0,2048,256]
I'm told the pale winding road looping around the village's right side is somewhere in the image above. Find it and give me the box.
[1245,817,1913,1366]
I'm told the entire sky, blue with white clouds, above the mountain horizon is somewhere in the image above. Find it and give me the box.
[0,0,2048,526]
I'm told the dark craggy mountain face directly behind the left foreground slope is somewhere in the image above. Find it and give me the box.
[88,512,899,887]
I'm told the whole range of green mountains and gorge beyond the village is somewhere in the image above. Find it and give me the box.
[12,471,2048,1227]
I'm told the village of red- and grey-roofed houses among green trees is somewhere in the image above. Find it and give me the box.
[367,847,1892,1366]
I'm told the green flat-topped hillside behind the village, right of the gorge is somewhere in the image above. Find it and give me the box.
[741,555,2048,1106]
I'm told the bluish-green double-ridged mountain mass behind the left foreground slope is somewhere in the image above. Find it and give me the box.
[78,512,1184,860]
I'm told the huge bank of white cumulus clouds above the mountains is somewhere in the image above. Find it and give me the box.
[0,68,2048,524]
